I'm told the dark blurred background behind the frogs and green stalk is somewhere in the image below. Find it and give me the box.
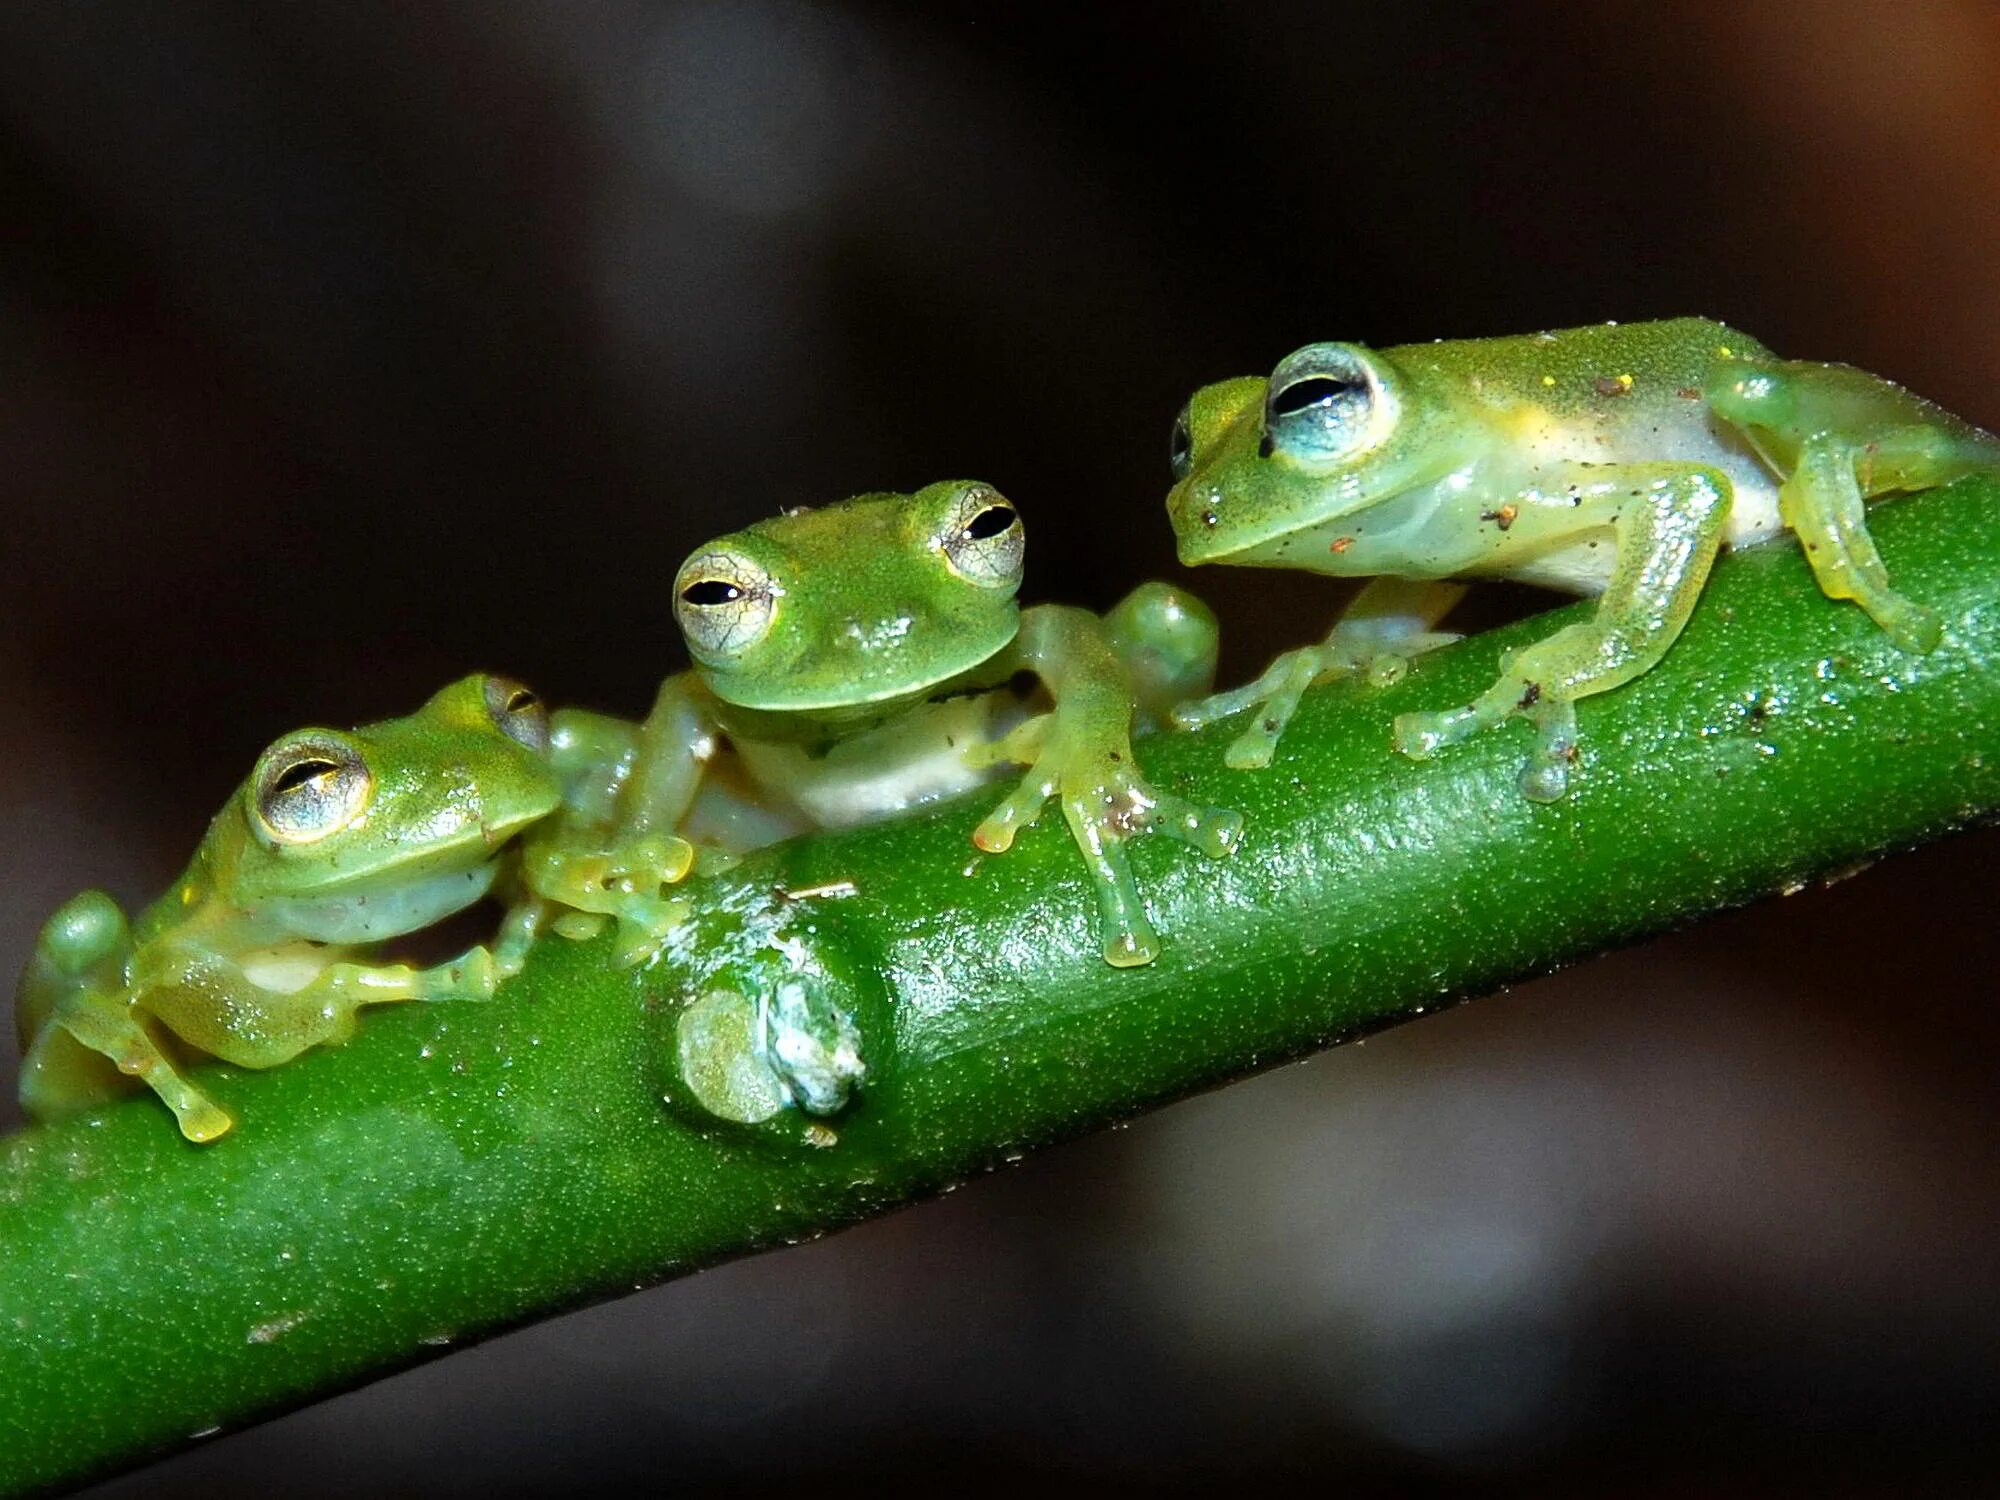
[0,0,2000,1498]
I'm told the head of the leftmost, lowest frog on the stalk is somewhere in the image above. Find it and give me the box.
[198,674,560,942]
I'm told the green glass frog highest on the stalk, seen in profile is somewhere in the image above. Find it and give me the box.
[1166,318,2000,802]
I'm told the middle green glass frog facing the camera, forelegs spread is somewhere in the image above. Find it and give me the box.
[526,482,1242,966]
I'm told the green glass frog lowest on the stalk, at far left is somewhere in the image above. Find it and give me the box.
[16,676,558,1140]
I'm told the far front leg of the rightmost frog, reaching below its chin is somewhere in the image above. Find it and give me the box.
[1172,576,1466,770]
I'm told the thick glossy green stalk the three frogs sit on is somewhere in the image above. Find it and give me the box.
[0,482,2000,1490]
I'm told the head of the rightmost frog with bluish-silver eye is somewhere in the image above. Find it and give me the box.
[1166,344,1448,566]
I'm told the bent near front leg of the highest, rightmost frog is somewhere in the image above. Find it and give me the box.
[1394,464,1730,802]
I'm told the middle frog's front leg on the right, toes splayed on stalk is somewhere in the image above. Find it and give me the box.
[966,604,1242,968]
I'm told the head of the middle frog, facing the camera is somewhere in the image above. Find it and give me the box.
[674,480,1024,714]
